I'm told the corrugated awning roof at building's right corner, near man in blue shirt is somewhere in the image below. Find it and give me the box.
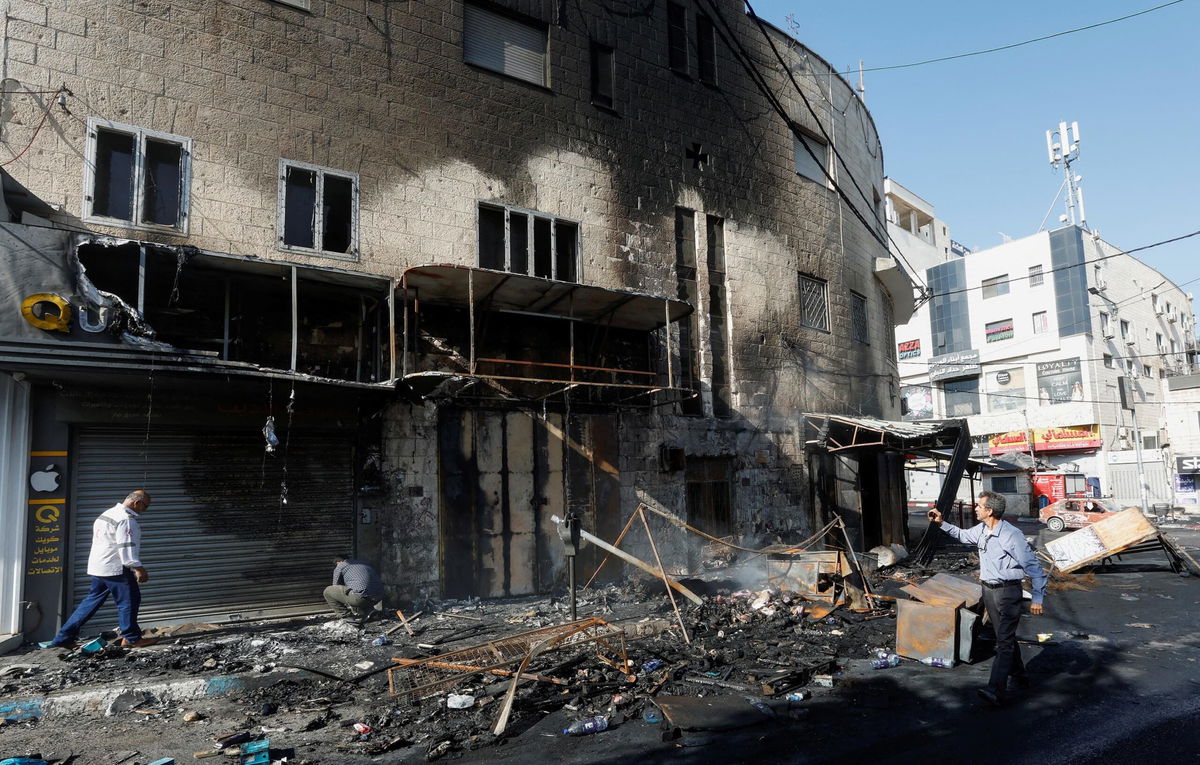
[804,414,965,452]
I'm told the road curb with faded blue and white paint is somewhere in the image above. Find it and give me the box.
[0,669,299,721]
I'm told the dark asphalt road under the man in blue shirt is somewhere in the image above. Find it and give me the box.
[451,524,1200,765]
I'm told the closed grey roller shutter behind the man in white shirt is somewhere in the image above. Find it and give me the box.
[72,428,354,628]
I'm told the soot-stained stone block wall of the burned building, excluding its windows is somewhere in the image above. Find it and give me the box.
[0,0,899,595]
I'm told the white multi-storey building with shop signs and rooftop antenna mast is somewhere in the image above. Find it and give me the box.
[888,185,1200,513]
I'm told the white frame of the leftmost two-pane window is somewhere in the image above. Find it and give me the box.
[83,116,192,236]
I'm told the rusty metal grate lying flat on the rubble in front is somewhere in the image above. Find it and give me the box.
[388,618,629,699]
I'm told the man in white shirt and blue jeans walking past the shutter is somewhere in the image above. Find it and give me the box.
[50,489,156,647]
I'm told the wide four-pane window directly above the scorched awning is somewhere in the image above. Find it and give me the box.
[479,204,580,282]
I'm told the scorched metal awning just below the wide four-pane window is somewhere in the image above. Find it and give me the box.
[401,265,692,331]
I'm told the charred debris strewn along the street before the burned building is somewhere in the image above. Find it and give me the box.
[0,513,973,763]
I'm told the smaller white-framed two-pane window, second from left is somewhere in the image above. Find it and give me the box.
[280,159,359,259]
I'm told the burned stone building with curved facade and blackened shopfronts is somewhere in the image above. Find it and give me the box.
[0,0,912,647]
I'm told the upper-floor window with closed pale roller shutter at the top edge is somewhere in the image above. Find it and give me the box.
[463,2,546,85]
